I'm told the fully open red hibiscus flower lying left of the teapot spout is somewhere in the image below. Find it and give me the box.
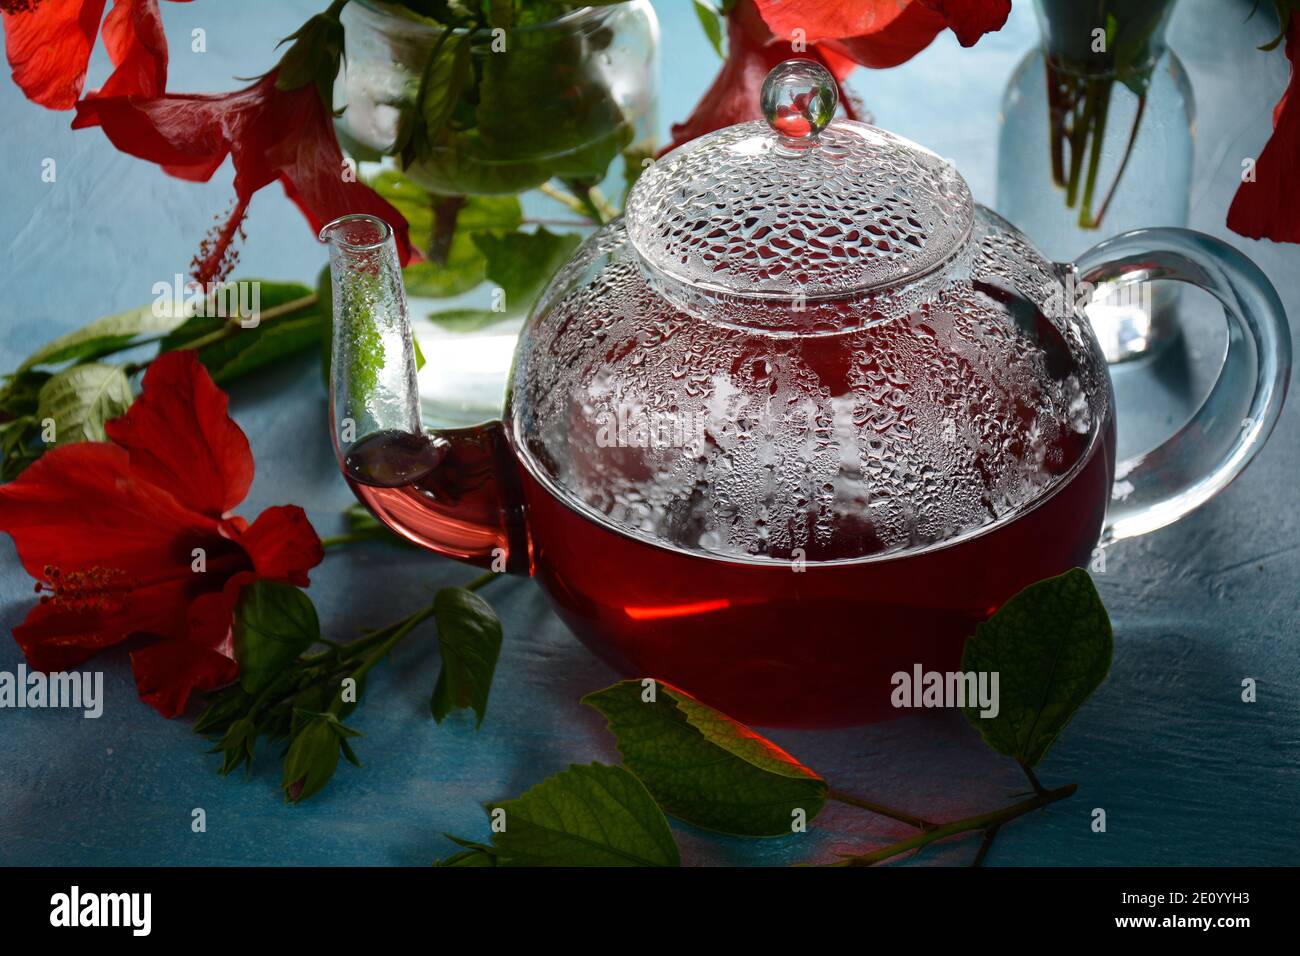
[0,351,324,717]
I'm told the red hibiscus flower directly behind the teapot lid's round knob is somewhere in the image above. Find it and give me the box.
[666,0,1011,152]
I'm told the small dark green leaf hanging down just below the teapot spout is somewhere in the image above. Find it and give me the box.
[430,588,502,726]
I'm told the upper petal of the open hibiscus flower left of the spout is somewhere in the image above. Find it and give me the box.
[104,350,254,518]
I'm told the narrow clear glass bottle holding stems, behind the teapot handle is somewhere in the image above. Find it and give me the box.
[997,0,1195,362]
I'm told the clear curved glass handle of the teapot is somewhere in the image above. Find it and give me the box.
[1075,228,1291,544]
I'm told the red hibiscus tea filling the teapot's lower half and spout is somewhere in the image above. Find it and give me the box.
[346,403,1114,726]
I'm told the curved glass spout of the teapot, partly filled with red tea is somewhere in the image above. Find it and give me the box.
[320,215,532,574]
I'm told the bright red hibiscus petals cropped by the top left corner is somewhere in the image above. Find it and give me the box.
[0,0,186,109]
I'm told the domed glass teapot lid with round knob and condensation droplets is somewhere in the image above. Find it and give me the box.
[627,60,974,302]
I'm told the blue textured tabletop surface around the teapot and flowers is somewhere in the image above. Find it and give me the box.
[0,0,1300,865]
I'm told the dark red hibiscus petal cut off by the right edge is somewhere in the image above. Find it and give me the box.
[1227,17,1300,242]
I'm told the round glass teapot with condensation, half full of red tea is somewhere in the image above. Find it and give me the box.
[321,60,1291,726]
